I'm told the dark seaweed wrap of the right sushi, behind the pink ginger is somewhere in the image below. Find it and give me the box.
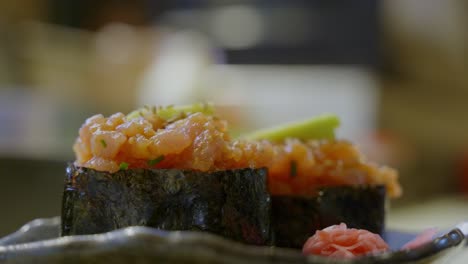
[272,186,386,248]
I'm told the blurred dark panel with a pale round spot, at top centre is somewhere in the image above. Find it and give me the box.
[162,0,380,65]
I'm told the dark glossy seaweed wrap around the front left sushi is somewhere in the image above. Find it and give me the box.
[62,165,272,245]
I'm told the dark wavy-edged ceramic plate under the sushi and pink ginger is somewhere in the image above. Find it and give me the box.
[0,217,466,264]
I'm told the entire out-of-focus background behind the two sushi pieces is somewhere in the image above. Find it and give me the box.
[0,0,468,236]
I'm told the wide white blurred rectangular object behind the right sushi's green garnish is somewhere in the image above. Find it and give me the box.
[205,65,379,140]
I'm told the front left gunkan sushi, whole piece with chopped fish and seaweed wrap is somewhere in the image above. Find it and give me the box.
[62,105,272,245]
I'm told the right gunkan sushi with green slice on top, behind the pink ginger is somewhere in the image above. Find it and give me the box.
[246,115,402,248]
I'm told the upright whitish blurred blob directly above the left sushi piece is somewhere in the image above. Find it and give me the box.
[137,29,213,105]
